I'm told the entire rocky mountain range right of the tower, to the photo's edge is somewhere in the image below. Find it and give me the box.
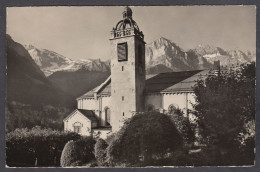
[146,37,256,74]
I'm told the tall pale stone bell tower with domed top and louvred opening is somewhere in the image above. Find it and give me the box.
[110,7,145,132]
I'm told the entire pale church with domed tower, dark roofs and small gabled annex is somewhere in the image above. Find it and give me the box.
[63,7,217,138]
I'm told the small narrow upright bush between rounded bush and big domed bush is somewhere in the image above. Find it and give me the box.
[95,138,108,166]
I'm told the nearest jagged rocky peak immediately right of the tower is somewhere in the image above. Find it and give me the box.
[146,37,211,73]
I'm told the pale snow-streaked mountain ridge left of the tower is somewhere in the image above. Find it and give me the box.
[24,45,110,76]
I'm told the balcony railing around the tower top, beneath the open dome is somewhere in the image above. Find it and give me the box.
[110,27,144,40]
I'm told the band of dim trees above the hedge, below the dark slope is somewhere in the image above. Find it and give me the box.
[5,102,71,132]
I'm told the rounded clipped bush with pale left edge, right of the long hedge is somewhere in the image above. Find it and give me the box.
[60,137,95,167]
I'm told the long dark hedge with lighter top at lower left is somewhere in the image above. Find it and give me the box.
[6,126,80,166]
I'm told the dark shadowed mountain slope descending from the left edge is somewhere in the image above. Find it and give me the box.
[6,35,70,105]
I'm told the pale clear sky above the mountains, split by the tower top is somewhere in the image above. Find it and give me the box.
[6,6,256,60]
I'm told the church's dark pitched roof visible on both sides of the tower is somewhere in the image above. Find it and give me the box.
[78,70,210,99]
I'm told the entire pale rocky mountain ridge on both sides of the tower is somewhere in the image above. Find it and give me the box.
[24,37,256,76]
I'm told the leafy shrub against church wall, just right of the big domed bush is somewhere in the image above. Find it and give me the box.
[168,108,195,145]
